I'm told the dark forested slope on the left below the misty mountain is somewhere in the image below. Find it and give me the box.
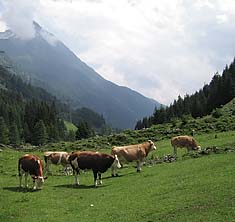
[0,65,112,145]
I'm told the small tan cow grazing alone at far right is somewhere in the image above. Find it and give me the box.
[171,136,201,157]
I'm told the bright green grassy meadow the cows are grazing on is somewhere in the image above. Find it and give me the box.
[0,131,235,222]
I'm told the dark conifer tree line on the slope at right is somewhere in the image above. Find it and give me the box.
[135,59,235,130]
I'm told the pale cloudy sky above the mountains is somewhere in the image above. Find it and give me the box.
[0,0,235,105]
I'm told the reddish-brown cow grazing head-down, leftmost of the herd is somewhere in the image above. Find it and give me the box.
[18,154,47,190]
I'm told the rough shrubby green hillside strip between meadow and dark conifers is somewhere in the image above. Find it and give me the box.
[40,99,235,151]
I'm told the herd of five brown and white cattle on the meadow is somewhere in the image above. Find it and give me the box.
[18,136,201,189]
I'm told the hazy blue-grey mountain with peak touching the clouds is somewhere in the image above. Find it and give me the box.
[0,22,160,128]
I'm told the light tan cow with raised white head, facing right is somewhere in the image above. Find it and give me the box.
[111,140,156,176]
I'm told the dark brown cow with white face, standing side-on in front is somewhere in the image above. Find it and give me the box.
[69,151,121,187]
